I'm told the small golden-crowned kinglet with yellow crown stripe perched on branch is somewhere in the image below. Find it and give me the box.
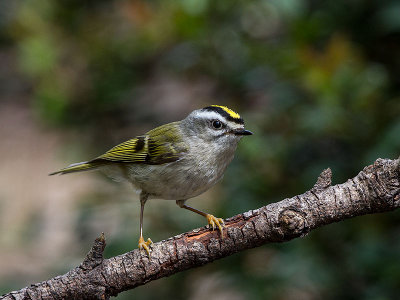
[50,105,252,255]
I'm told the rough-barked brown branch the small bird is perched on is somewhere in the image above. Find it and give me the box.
[0,159,400,299]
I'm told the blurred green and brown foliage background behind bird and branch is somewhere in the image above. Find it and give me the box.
[0,0,400,300]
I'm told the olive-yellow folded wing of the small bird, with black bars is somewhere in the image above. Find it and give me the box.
[90,123,187,165]
